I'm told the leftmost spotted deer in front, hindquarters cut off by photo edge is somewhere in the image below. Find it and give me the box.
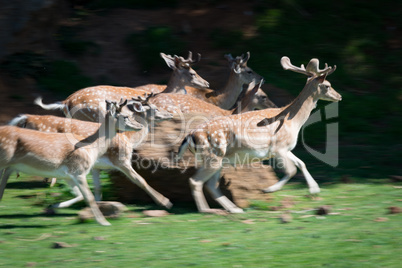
[0,101,144,225]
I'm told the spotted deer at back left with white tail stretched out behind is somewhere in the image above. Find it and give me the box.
[35,52,209,122]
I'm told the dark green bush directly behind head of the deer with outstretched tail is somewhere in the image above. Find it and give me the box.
[127,26,188,71]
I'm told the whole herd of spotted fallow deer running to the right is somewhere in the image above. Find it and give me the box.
[0,52,342,225]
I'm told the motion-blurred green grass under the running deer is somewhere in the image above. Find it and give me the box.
[0,177,402,267]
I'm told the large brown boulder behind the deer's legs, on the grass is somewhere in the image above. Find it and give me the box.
[111,114,277,207]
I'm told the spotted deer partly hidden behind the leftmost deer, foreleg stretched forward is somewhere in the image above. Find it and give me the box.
[0,99,173,209]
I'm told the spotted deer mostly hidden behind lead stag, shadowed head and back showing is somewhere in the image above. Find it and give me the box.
[148,79,264,117]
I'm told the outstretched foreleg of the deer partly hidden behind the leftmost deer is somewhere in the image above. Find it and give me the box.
[116,163,172,209]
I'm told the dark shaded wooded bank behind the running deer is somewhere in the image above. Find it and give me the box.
[0,0,402,182]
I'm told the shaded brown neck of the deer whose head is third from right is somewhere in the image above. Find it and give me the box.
[215,71,243,110]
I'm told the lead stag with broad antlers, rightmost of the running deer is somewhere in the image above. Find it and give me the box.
[177,56,342,213]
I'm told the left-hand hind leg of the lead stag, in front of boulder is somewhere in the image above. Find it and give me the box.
[189,167,220,212]
